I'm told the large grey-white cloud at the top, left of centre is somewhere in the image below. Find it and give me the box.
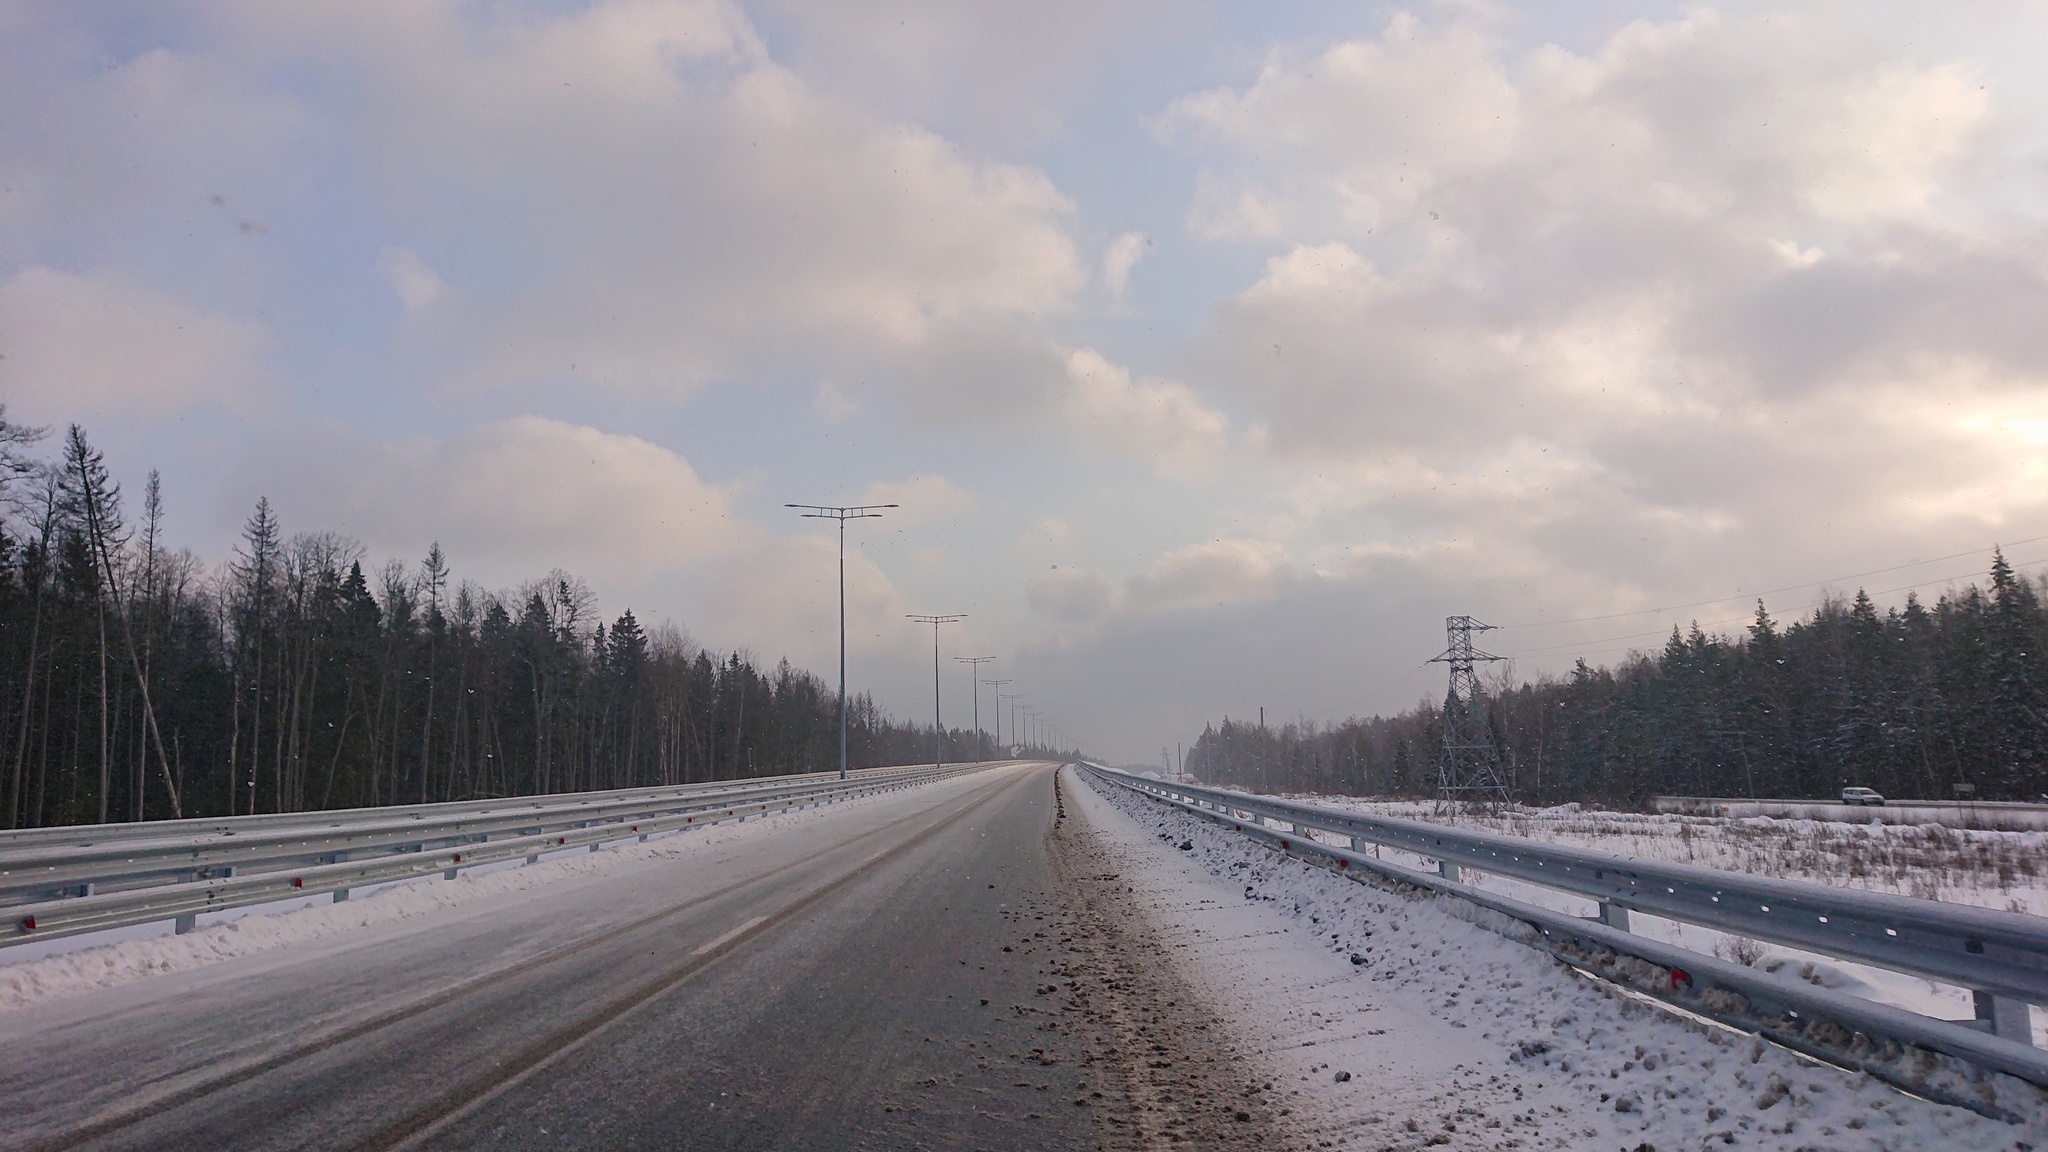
[274,0,1085,389]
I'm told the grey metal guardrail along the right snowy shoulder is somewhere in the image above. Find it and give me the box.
[1085,765,2048,1119]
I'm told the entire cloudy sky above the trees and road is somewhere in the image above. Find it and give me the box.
[0,0,2048,760]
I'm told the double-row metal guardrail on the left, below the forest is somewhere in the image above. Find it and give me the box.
[0,763,1007,947]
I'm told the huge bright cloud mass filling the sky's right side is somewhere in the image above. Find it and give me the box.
[1157,10,2048,588]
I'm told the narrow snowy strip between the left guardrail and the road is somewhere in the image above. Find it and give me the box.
[0,778,913,1013]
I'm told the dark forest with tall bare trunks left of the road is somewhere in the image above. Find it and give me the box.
[0,406,1011,828]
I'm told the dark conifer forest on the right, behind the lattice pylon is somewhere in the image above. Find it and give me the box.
[1186,553,2048,806]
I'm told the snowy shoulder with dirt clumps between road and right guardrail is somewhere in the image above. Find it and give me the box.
[1073,766,2048,1152]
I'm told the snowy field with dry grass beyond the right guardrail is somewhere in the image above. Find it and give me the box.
[1245,795,2048,1041]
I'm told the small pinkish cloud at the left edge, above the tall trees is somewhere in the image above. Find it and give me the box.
[0,266,274,420]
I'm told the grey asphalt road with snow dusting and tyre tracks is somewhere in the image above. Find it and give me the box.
[0,765,1286,1150]
